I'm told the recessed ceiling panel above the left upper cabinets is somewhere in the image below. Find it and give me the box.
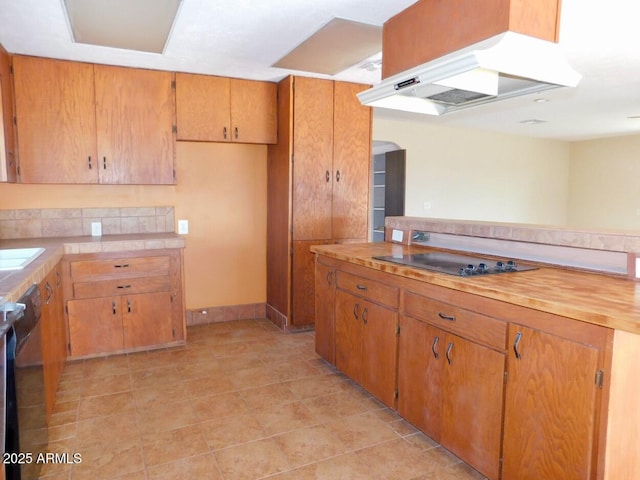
[63,0,182,53]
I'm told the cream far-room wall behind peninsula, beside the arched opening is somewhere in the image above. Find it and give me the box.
[373,116,570,225]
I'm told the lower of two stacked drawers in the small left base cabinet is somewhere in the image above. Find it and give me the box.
[73,276,171,299]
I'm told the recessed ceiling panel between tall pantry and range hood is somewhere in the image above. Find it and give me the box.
[273,18,382,75]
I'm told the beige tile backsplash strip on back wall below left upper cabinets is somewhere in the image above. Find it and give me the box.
[0,207,175,240]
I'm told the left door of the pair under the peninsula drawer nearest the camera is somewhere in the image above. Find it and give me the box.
[398,316,446,441]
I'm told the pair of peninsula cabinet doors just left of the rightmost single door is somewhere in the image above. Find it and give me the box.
[398,316,505,479]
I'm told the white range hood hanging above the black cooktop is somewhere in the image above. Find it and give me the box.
[358,32,581,115]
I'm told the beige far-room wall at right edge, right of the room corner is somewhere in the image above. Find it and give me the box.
[567,135,640,230]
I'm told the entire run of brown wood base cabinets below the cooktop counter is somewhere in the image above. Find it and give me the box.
[316,256,614,480]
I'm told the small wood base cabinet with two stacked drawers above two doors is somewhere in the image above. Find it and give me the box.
[64,249,185,357]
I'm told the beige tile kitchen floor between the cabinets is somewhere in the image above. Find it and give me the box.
[40,320,483,480]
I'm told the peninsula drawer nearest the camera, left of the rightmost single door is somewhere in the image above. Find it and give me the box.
[404,292,507,350]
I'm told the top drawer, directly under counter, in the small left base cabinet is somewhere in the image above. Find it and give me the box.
[71,255,170,282]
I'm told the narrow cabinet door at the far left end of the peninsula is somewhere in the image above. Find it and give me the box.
[315,262,336,365]
